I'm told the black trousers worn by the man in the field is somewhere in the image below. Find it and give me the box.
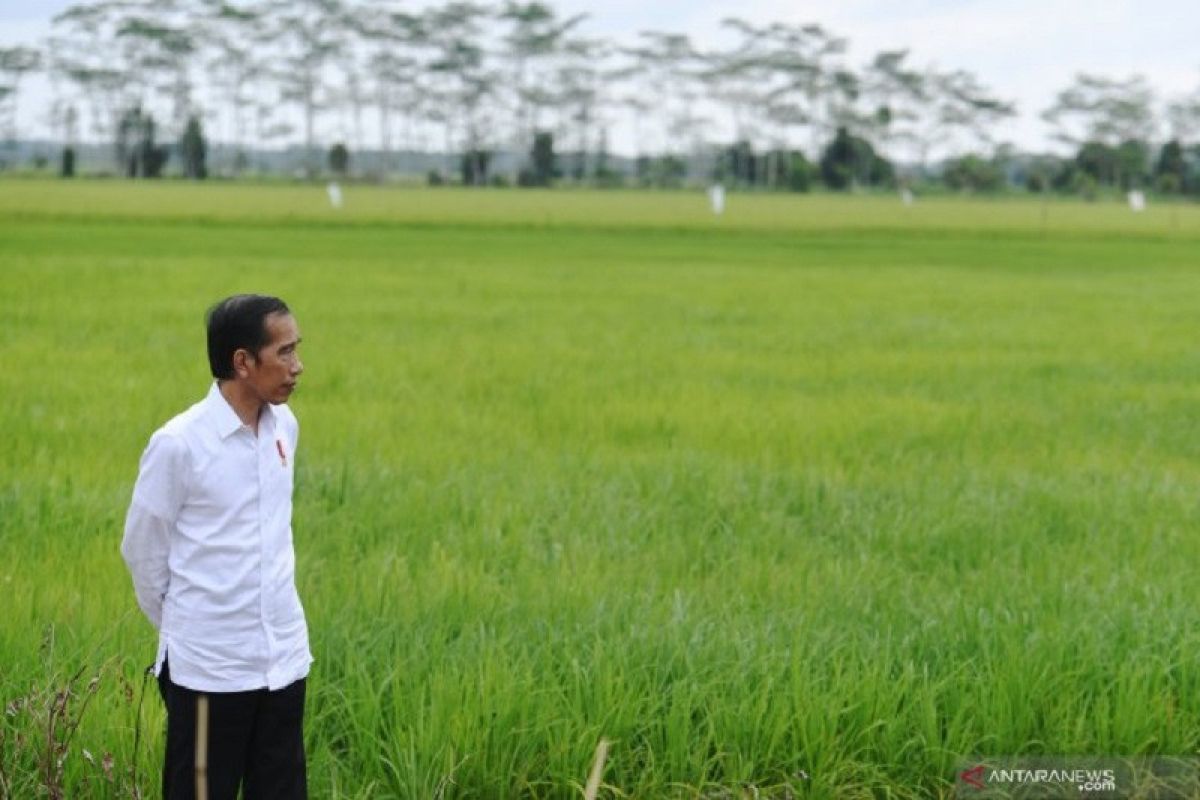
[158,662,308,800]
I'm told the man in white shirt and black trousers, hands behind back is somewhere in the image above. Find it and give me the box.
[121,295,312,800]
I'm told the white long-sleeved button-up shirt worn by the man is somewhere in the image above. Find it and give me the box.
[121,383,312,692]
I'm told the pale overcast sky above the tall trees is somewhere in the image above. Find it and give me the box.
[0,0,1200,154]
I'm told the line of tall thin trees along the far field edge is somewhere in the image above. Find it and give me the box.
[0,0,1200,193]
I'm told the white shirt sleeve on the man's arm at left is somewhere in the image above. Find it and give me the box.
[121,432,187,628]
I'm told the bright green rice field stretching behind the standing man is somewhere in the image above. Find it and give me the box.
[0,180,1200,800]
